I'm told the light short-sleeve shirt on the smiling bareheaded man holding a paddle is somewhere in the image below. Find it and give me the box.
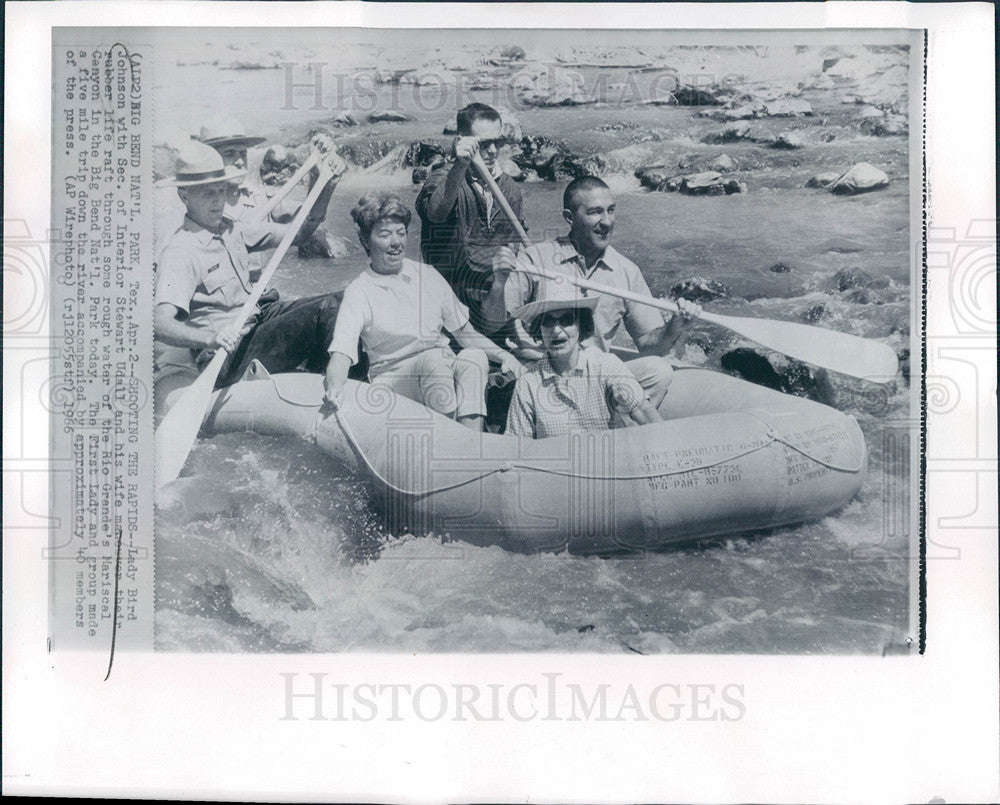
[504,238,664,351]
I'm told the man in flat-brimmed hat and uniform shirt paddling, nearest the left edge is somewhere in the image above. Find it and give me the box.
[153,140,346,388]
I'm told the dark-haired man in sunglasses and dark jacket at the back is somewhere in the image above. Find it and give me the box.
[416,103,523,332]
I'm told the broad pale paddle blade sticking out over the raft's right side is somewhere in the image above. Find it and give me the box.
[702,313,899,383]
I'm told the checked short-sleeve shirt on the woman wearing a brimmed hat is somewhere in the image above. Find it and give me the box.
[507,347,648,439]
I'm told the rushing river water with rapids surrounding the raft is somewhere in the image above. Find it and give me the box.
[156,39,916,653]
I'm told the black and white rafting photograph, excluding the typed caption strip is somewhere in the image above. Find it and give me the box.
[145,29,922,654]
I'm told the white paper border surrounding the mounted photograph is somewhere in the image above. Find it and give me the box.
[3,2,1000,802]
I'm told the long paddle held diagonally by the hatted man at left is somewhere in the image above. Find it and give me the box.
[154,162,332,490]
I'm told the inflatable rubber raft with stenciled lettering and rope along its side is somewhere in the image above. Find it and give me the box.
[161,367,867,553]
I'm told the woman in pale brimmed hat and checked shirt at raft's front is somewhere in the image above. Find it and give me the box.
[507,282,663,439]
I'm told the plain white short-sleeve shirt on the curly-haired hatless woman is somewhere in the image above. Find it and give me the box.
[329,258,469,376]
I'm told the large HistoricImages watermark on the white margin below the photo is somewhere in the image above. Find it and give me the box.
[279,672,747,723]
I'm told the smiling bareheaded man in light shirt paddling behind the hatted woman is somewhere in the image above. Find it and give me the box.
[484,176,701,408]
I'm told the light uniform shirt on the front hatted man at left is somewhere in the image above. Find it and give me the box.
[156,218,285,332]
